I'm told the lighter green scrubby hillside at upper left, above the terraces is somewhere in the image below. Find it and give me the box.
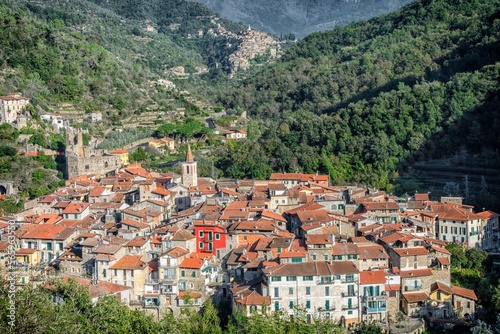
[0,0,249,120]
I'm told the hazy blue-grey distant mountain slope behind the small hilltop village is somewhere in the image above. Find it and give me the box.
[189,0,411,38]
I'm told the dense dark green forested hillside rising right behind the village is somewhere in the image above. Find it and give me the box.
[219,0,500,197]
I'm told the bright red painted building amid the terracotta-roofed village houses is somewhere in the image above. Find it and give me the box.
[194,220,227,258]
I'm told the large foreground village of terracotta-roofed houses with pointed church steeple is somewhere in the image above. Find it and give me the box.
[0,147,500,332]
